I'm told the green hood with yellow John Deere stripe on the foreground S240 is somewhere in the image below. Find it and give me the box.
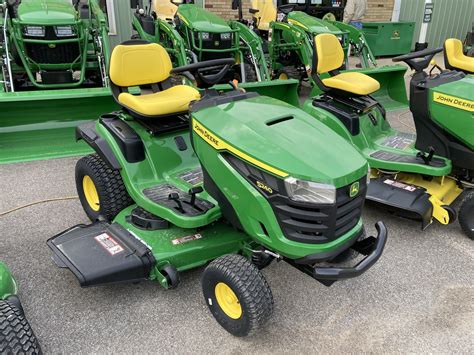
[193,96,368,188]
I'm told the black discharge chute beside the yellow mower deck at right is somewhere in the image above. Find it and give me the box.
[366,177,433,229]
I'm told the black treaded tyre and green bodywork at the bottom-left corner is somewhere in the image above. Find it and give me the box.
[0,262,41,355]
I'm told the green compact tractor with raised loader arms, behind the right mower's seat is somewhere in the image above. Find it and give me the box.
[234,0,408,110]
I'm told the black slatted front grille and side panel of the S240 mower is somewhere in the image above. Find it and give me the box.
[225,154,367,244]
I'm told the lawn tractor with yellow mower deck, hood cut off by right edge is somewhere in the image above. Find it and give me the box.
[304,34,474,239]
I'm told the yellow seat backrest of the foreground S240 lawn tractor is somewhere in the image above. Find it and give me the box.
[109,41,173,87]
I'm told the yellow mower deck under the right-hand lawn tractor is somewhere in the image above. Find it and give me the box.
[397,174,463,224]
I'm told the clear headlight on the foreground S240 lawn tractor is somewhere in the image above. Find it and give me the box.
[285,177,336,204]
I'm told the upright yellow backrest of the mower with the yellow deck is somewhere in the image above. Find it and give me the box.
[313,33,344,74]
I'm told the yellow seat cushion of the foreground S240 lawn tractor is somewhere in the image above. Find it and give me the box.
[118,85,201,116]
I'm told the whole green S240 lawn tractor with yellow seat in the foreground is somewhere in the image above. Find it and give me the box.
[48,41,387,336]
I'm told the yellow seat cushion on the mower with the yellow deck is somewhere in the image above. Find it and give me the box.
[322,72,380,95]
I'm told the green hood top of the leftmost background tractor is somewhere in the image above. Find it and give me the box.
[18,0,77,25]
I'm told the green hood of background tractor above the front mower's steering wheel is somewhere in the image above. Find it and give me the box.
[177,4,232,33]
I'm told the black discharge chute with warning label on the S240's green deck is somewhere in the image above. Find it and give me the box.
[47,222,155,287]
